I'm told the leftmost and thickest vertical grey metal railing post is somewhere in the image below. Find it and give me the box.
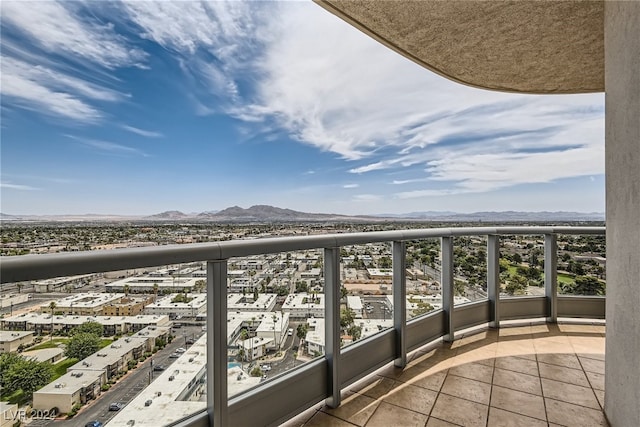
[207,260,229,427]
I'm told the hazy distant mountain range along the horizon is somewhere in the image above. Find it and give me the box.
[0,205,604,223]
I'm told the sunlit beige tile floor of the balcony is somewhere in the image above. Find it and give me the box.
[283,323,608,427]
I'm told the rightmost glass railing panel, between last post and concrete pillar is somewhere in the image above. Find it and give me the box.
[557,234,607,296]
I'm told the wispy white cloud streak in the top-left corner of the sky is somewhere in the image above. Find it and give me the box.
[2,1,146,69]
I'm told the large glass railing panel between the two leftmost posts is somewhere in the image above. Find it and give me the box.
[227,249,325,397]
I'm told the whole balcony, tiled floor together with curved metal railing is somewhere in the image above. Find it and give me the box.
[0,227,605,426]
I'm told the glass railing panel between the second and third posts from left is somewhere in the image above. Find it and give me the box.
[340,242,393,347]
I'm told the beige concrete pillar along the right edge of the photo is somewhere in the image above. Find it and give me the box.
[604,1,640,427]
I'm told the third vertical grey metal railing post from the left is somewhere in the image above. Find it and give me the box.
[392,242,407,368]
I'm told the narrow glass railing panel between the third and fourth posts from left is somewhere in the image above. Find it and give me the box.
[406,239,442,320]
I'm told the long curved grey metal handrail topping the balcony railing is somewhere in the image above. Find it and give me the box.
[0,226,605,283]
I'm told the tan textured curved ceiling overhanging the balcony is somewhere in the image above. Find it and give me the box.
[316,0,604,93]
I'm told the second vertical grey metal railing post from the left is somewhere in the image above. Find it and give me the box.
[324,248,340,408]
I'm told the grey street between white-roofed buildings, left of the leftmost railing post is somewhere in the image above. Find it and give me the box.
[29,326,202,427]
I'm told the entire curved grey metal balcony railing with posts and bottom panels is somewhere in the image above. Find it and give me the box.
[0,227,605,426]
